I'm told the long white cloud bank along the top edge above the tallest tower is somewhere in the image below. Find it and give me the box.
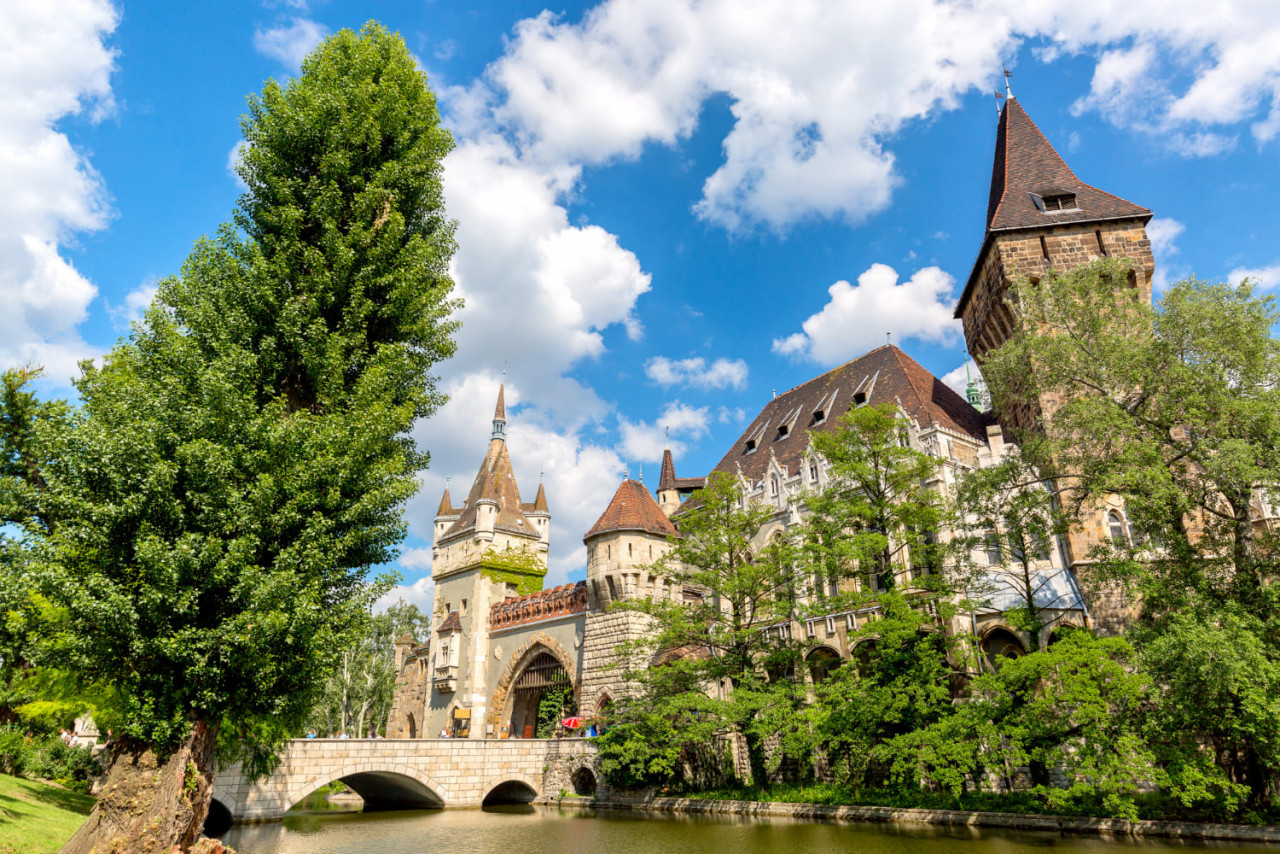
[472,0,1280,229]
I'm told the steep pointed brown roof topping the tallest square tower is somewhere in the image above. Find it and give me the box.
[987,99,1151,232]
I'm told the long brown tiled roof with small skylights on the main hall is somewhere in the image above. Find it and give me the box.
[714,344,987,483]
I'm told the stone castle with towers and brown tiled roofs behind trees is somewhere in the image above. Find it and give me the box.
[387,97,1155,737]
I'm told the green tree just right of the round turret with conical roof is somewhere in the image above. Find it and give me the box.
[611,472,803,778]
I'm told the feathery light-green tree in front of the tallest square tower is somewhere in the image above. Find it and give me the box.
[983,260,1280,808]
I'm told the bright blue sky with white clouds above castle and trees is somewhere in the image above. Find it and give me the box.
[0,0,1280,612]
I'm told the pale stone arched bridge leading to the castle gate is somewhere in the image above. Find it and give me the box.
[210,739,595,822]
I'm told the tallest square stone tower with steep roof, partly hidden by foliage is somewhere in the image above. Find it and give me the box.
[955,96,1155,629]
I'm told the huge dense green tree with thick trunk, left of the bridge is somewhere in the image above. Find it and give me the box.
[0,24,454,851]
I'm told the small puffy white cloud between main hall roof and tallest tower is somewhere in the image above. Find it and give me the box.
[773,264,960,365]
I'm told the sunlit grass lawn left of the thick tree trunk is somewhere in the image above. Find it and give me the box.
[0,773,93,854]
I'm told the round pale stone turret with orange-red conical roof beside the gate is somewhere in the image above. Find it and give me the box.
[579,471,682,717]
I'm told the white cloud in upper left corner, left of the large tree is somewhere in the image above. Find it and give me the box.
[0,0,119,382]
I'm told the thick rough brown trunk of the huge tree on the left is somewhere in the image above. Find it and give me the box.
[60,721,224,854]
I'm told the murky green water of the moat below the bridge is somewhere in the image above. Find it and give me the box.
[224,807,1275,854]
